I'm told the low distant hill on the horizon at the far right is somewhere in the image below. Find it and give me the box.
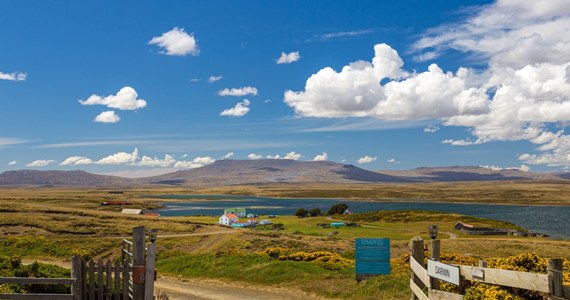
[377,166,560,182]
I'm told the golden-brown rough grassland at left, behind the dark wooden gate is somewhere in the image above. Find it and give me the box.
[0,189,229,259]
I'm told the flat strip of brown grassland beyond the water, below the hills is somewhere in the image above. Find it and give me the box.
[129,181,570,205]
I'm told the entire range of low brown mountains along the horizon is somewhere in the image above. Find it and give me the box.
[0,159,570,187]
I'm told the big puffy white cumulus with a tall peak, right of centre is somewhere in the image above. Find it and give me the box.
[284,44,488,120]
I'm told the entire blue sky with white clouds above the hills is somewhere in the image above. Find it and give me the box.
[0,0,570,177]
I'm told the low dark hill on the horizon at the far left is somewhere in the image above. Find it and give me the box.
[0,170,133,187]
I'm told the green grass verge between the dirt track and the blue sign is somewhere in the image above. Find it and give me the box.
[157,250,409,299]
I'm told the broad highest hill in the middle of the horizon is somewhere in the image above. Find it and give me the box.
[138,159,410,185]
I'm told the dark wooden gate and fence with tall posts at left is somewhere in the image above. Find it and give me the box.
[0,226,156,300]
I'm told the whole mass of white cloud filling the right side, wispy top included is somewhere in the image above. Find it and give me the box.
[284,0,570,166]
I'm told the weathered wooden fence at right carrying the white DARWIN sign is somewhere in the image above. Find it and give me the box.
[410,237,570,300]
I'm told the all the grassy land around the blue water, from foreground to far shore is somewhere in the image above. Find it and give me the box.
[0,183,570,299]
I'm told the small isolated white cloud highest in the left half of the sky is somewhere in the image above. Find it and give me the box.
[148,27,200,56]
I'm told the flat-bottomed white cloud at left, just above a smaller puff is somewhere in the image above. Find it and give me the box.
[79,86,146,110]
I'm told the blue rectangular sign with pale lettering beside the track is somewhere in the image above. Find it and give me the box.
[355,239,390,276]
